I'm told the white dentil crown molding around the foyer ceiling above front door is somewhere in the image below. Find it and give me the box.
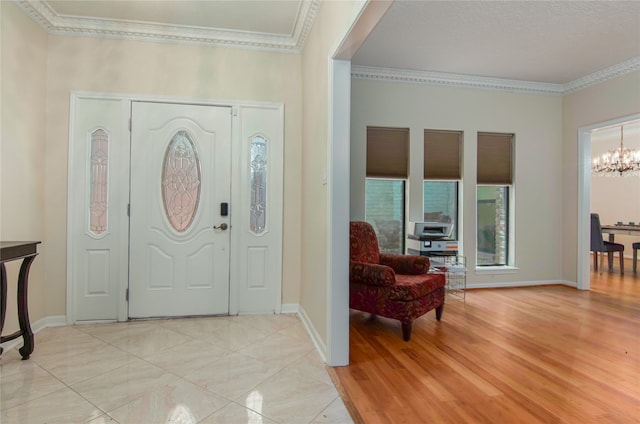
[14,0,320,53]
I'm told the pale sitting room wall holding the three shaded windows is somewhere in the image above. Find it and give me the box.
[351,79,564,286]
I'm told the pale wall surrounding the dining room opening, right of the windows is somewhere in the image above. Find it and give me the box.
[562,71,640,281]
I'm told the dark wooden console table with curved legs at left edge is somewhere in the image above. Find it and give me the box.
[0,241,40,360]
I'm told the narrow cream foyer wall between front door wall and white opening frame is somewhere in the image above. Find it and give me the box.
[300,1,363,350]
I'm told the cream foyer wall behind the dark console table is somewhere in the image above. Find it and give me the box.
[0,1,49,334]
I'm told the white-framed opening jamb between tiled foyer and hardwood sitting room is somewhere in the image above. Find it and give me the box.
[325,0,393,367]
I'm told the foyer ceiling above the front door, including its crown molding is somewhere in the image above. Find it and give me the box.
[18,0,320,53]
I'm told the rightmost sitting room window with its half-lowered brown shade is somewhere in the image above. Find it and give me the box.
[476,133,514,266]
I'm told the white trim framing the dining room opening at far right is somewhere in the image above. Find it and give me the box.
[577,114,640,290]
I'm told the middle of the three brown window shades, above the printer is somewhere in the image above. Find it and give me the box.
[424,130,462,180]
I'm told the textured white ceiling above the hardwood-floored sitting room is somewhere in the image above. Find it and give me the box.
[352,0,640,84]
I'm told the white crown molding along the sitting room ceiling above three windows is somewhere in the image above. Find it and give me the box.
[351,57,640,96]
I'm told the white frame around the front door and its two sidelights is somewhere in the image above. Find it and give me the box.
[66,91,284,324]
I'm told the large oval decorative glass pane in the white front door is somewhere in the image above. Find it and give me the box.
[162,131,201,232]
